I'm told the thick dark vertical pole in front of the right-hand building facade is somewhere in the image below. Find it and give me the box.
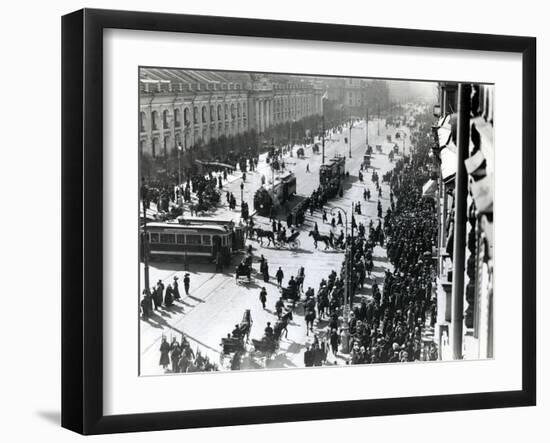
[451,83,471,360]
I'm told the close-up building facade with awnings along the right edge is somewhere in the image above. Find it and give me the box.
[433,83,495,360]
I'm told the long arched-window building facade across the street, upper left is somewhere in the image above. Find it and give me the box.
[139,68,323,158]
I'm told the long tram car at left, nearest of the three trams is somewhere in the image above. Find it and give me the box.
[142,220,244,264]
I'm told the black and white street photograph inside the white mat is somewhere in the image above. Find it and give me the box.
[135,66,498,376]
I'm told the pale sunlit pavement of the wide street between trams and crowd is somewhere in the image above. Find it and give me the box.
[140,119,418,375]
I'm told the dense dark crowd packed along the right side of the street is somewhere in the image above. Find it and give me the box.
[294,116,438,366]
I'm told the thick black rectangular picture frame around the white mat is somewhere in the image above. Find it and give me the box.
[62,9,537,434]
